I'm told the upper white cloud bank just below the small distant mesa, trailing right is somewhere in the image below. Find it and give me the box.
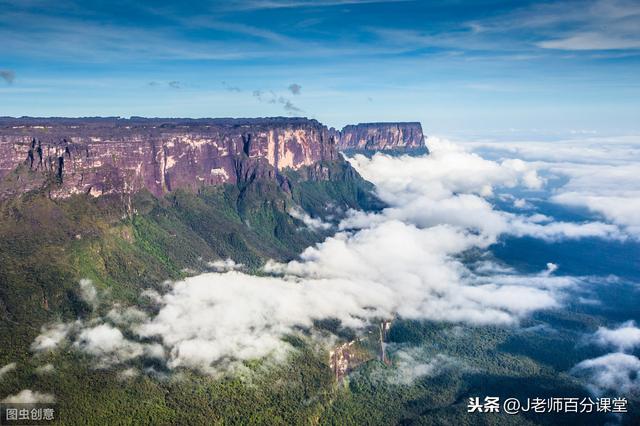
[340,138,622,240]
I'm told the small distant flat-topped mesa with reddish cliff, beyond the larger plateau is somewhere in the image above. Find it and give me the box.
[340,123,426,151]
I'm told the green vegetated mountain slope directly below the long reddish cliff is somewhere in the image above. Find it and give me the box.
[0,155,380,354]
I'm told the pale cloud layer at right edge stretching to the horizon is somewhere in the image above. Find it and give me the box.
[465,136,640,238]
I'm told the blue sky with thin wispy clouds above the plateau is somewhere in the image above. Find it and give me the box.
[0,0,640,134]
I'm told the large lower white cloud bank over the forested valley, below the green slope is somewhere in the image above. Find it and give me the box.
[135,220,575,371]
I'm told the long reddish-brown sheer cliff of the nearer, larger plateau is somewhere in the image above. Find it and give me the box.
[0,118,339,197]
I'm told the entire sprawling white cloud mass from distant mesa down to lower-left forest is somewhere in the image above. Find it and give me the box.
[33,136,623,376]
